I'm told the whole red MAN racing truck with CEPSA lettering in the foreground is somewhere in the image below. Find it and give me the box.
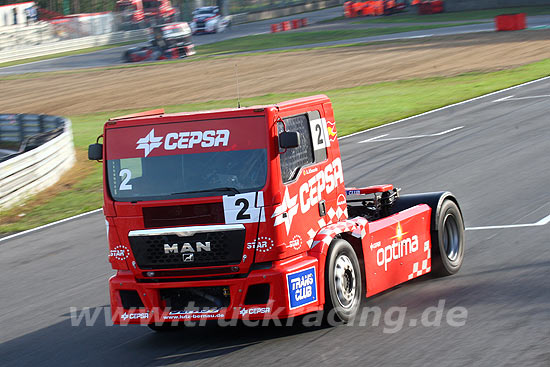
[88,95,464,330]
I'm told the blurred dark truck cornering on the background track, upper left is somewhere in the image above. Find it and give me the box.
[122,22,195,62]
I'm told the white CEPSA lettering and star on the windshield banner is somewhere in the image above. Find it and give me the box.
[136,129,230,157]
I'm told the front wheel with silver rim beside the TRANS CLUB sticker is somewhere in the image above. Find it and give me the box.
[324,239,363,323]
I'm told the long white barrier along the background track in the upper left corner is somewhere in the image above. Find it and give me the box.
[0,29,148,63]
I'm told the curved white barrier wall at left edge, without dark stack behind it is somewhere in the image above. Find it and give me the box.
[0,119,75,209]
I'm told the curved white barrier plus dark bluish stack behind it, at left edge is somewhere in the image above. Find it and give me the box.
[0,114,75,209]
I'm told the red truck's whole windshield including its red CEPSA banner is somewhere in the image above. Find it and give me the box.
[105,117,267,201]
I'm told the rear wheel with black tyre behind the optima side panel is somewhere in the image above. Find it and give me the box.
[432,200,465,277]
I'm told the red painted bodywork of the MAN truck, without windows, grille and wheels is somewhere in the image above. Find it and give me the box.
[98,95,431,323]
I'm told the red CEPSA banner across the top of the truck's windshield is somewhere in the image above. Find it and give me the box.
[106,117,266,160]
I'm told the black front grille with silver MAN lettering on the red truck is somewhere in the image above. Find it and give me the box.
[129,229,245,269]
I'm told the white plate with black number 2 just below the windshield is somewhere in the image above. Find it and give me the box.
[223,191,265,224]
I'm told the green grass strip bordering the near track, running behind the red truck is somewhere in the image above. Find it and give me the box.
[0,59,550,233]
